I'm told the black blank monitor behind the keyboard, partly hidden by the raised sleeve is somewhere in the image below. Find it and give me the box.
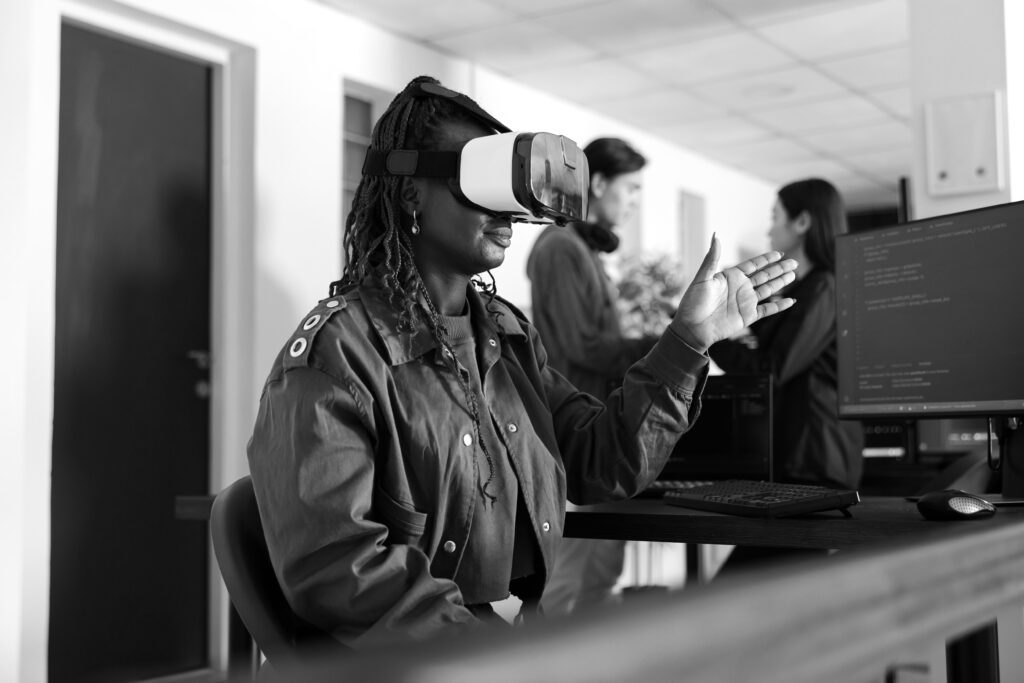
[658,374,772,481]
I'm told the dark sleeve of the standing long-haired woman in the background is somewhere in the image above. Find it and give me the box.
[709,280,836,385]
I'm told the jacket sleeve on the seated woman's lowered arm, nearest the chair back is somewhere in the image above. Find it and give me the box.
[248,368,479,647]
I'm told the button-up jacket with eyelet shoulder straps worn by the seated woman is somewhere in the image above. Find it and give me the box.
[248,287,708,647]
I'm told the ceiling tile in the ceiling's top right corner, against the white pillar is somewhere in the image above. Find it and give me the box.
[756,0,909,60]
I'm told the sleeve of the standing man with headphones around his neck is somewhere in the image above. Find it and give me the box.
[532,232,654,377]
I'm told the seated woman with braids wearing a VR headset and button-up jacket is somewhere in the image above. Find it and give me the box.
[248,77,795,647]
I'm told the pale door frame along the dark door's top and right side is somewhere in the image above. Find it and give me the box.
[54,0,256,671]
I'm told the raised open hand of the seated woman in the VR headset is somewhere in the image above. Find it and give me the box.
[670,237,797,352]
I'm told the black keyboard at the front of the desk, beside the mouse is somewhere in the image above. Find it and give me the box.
[662,479,860,517]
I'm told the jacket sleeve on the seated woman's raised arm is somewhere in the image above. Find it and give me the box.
[535,329,708,505]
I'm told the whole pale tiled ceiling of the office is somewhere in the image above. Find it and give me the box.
[323,0,910,207]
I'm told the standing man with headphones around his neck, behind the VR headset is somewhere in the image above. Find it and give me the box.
[526,137,655,614]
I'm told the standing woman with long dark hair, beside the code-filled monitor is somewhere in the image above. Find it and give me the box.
[710,178,863,488]
